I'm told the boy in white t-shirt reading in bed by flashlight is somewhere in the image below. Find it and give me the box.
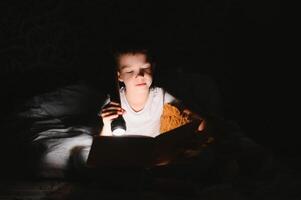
[100,44,205,137]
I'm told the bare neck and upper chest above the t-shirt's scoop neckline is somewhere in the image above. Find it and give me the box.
[125,90,149,112]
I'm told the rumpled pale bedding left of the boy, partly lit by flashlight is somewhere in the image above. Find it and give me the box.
[8,83,106,177]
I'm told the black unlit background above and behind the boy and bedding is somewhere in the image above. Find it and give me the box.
[0,0,300,159]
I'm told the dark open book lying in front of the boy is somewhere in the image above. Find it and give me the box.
[87,121,210,168]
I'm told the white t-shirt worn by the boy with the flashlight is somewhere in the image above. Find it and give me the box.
[107,87,178,137]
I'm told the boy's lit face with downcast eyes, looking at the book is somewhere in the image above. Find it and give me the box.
[118,53,153,91]
